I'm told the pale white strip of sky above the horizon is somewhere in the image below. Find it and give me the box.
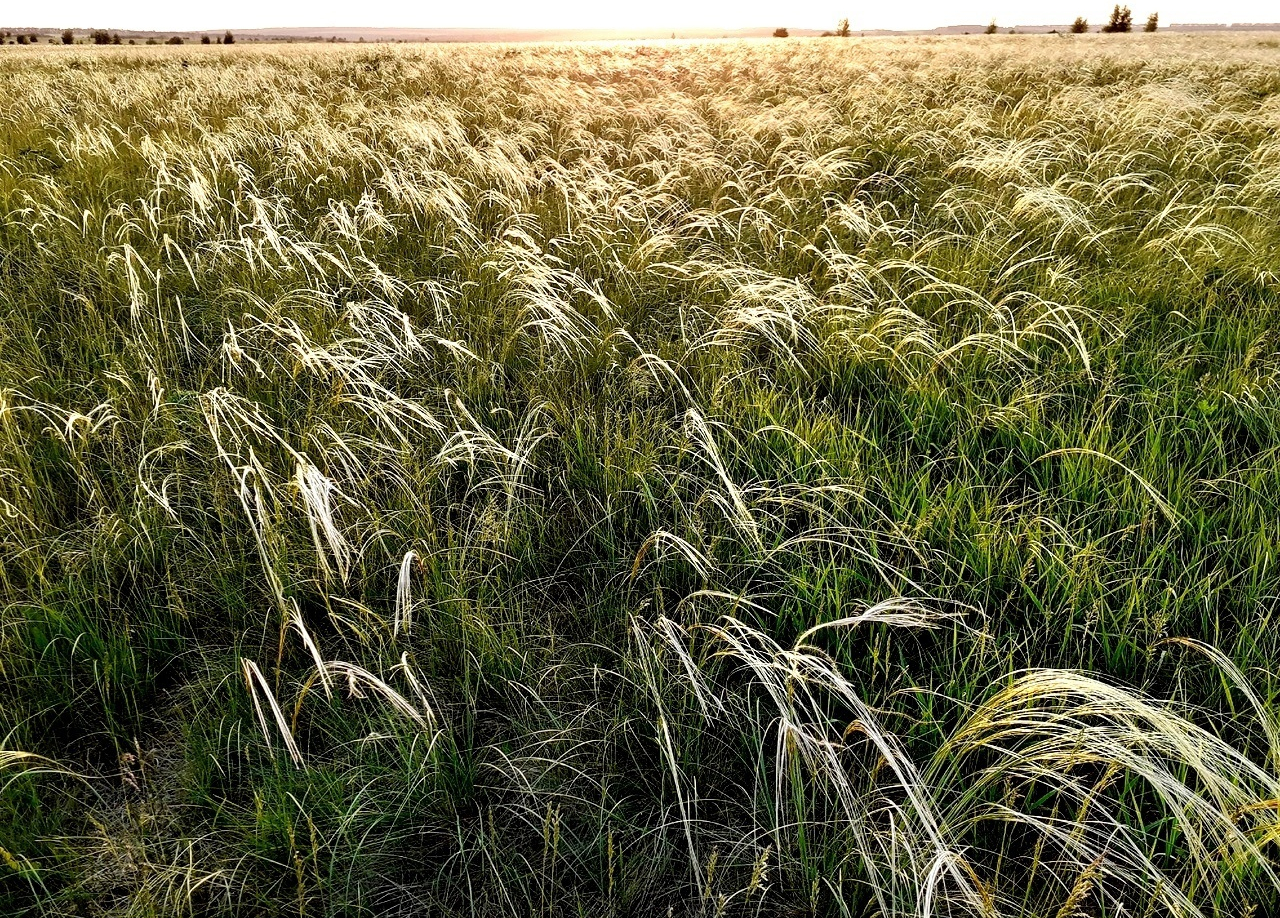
[10,0,1280,31]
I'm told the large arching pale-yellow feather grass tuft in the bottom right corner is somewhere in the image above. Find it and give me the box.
[928,670,1280,914]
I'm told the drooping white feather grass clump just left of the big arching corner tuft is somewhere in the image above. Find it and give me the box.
[632,600,993,915]
